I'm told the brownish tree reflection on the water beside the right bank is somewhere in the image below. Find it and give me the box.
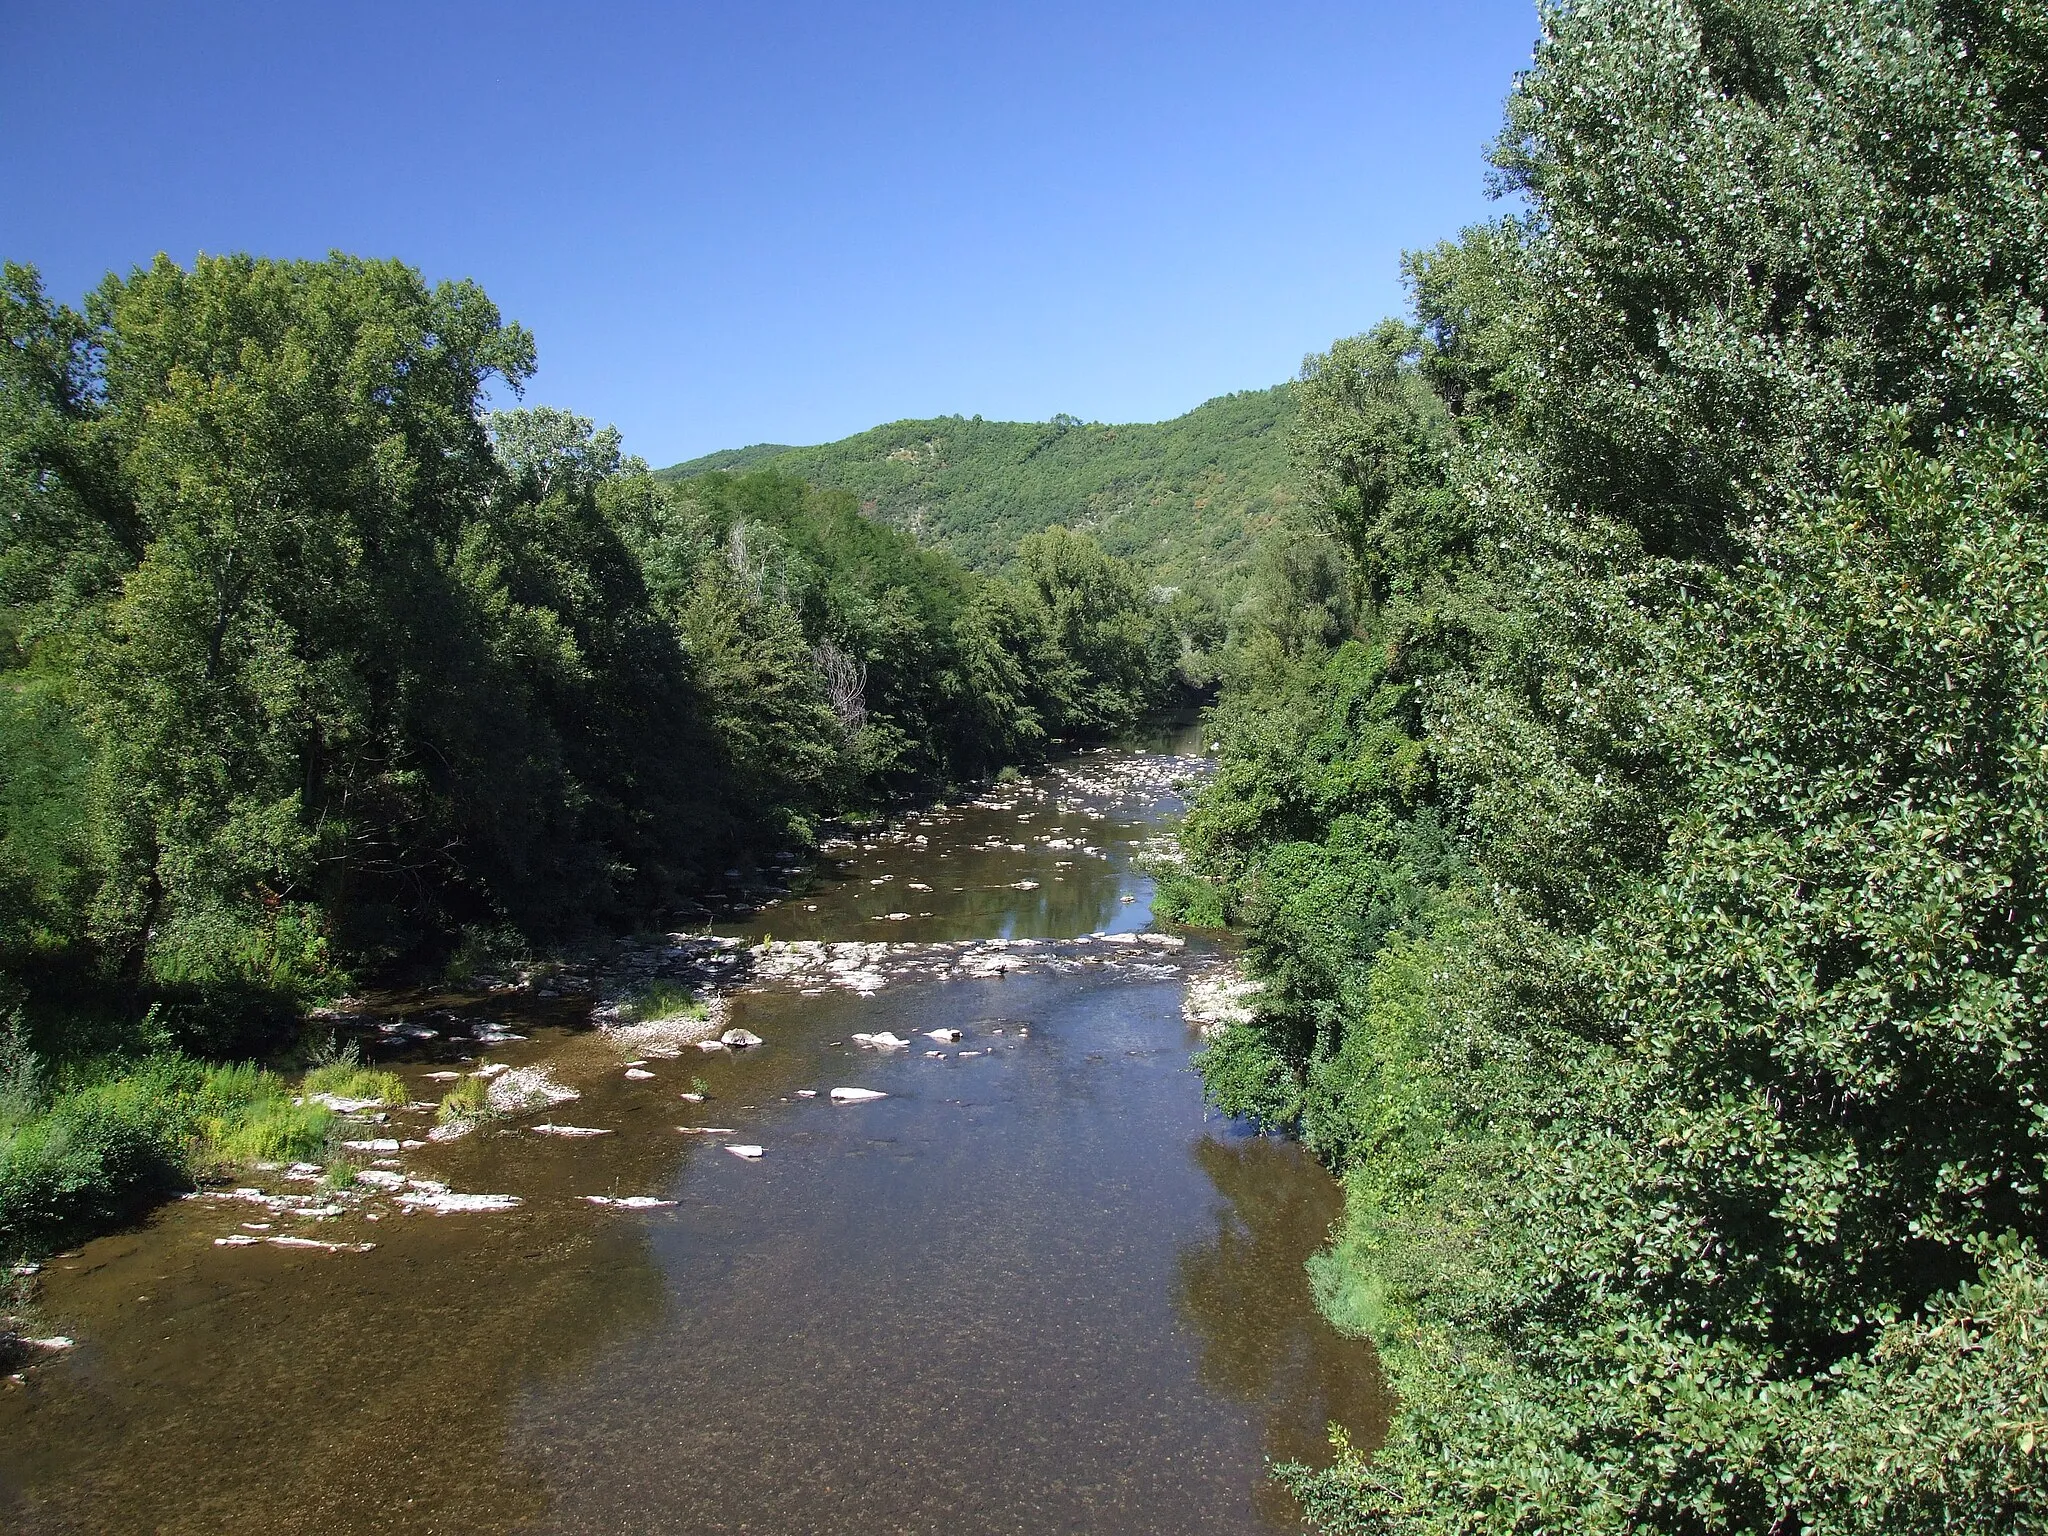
[1174,1133,1391,1520]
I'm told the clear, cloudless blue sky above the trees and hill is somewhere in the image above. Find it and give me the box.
[0,0,1536,465]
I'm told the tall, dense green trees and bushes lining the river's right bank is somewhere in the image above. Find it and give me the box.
[1169,0,2048,1534]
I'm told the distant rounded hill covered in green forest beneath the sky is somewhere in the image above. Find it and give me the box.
[657,385,1294,586]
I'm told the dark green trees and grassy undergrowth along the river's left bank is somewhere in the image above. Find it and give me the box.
[0,256,1200,1253]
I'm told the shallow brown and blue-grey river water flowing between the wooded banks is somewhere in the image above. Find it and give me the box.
[0,739,1386,1536]
